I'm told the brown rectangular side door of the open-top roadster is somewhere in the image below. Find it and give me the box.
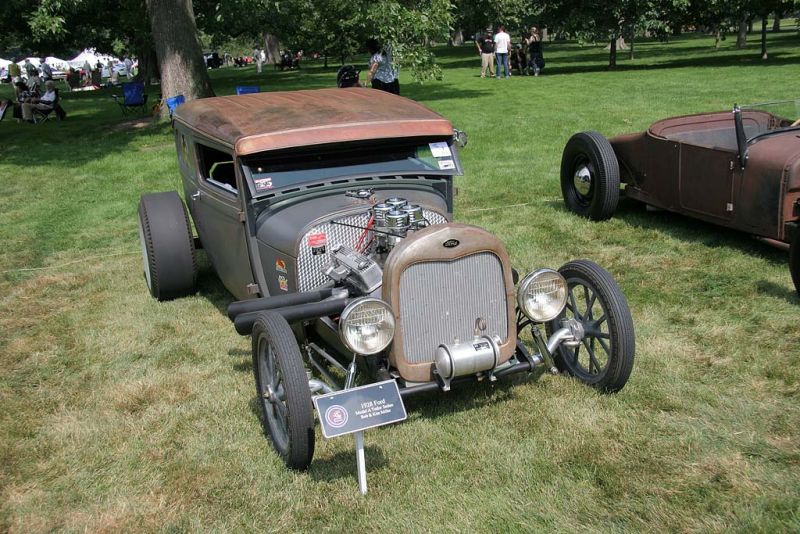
[678,143,739,222]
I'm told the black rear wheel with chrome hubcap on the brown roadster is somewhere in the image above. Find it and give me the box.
[561,132,619,221]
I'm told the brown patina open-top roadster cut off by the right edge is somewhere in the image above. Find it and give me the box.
[561,100,800,293]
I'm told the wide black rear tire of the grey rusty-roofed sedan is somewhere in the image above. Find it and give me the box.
[139,191,197,301]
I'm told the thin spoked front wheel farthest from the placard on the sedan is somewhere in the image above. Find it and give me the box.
[547,260,636,393]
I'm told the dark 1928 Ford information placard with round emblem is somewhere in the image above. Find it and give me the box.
[314,380,407,438]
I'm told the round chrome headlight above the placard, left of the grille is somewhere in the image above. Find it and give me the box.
[339,297,394,354]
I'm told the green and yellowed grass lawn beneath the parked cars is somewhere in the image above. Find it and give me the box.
[0,31,800,532]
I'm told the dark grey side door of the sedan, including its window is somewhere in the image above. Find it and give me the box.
[187,141,256,299]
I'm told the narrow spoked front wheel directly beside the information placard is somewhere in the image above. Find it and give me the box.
[252,311,314,471]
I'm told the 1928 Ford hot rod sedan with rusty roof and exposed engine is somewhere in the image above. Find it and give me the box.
[139,88,634,469]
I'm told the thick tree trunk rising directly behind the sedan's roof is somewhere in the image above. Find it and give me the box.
[146,0,214,117]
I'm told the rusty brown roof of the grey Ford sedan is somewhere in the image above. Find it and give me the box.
[174,87,453,156]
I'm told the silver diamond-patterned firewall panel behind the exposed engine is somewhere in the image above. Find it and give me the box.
[297,210,447,291]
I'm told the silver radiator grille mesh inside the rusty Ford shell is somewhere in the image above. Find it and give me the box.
[399,252,508,363]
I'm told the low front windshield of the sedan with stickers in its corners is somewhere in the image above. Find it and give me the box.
[244,141,457,196]
